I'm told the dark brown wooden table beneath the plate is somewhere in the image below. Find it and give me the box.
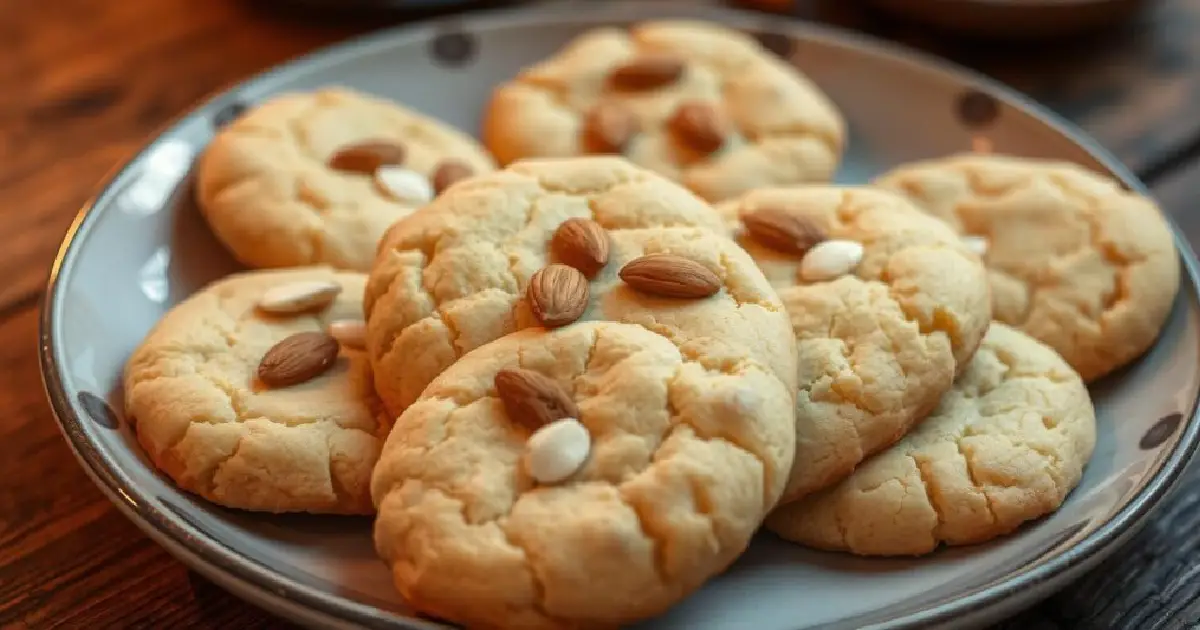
[0,0,1200,630]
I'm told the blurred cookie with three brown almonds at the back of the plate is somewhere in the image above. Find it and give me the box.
[484,20,845,200]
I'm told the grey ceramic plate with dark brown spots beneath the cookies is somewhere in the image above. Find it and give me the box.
[41,0,1200,630]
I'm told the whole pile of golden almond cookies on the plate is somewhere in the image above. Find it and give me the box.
[125,17,1180,628]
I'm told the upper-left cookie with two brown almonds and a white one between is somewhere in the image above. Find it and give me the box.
[196,88,494,271]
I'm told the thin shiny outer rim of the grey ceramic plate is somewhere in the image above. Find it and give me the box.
[38,0,1200,630]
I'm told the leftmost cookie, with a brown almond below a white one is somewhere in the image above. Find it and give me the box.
[125,268,390,514]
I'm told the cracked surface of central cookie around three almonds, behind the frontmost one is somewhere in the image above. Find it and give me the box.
[364,156,796,436]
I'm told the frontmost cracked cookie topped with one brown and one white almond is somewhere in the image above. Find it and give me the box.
[371,322,792,629]
